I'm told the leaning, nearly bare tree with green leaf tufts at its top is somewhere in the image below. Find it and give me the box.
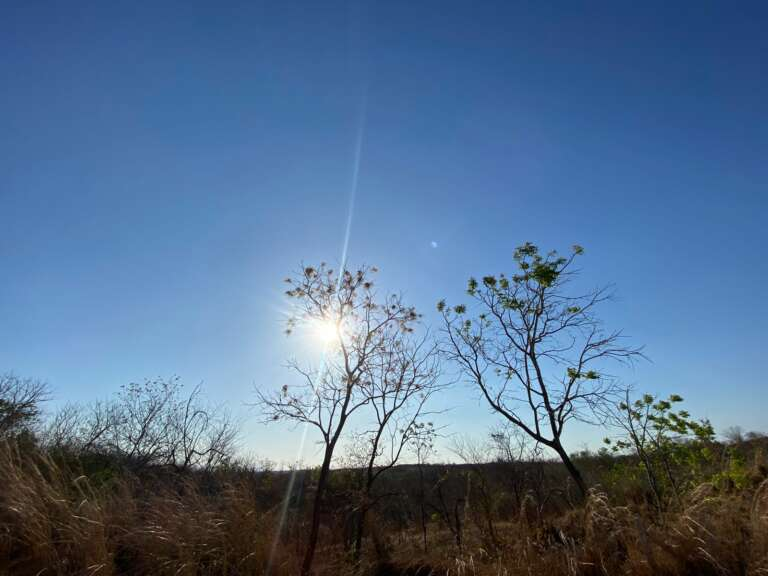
[438,243,640,495]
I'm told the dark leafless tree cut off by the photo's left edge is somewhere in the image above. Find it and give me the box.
[0,373,50,437]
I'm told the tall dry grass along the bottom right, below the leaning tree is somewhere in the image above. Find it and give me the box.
[381,480,768,576]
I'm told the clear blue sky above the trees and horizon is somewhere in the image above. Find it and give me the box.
[0,1,768,460]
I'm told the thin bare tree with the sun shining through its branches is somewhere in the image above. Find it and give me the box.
[257,264,419,576]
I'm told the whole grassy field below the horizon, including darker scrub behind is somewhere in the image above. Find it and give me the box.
[0,438,768,576]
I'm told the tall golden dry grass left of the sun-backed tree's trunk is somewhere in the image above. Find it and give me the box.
[0,443,296,576]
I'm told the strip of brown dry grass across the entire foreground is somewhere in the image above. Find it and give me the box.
[0,444,768,576]
